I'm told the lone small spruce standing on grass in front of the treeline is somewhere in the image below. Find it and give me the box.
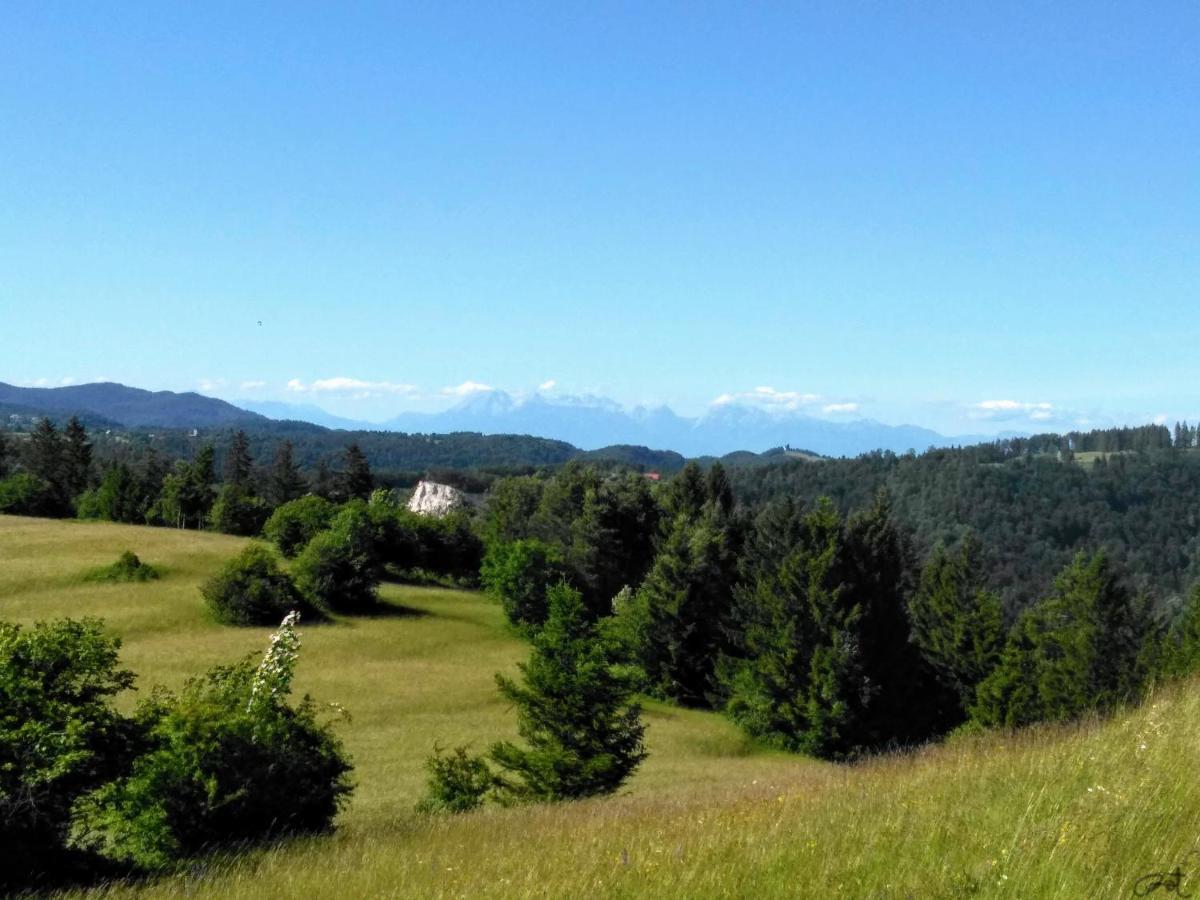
[490,583,646,800]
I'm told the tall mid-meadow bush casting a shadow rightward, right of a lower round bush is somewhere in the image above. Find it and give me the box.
[293,502,383,613]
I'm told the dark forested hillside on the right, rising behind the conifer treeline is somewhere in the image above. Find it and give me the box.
[730,428,1200,610]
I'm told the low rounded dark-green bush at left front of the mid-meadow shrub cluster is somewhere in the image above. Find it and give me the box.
[200,544,313,625]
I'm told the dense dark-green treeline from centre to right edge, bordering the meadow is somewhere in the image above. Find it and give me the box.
[482,464,1200,758]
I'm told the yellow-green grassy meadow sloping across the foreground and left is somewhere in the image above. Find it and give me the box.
[0,517,1200,899]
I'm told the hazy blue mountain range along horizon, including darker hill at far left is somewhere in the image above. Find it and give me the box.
[0,383,991,457]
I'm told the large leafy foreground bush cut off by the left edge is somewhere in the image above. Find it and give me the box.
[0,619,133,892]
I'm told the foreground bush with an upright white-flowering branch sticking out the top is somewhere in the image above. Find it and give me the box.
[78,613,352,869]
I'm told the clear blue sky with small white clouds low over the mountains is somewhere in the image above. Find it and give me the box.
[0,2,1200,432]
